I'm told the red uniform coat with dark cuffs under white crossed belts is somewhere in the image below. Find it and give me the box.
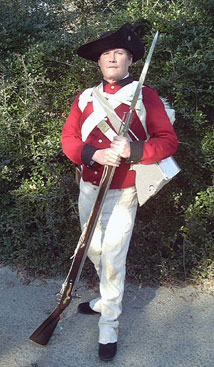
[61,83,177,189]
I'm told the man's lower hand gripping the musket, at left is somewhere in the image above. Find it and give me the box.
[92,148,121,167]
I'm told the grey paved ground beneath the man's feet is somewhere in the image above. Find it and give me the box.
[0,267,214,367]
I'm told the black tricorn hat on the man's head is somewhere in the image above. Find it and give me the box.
[77,23,145,62]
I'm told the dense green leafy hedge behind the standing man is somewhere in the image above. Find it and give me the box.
[0,0,214,282]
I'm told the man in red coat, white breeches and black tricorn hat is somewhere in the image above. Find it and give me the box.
[62,24,177,361]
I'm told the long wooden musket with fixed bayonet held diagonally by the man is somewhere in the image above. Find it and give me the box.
[30,32,158,346]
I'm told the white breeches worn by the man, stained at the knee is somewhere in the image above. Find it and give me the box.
[79,180,138,344]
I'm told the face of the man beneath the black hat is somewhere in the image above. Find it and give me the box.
[98,48,132,83]
